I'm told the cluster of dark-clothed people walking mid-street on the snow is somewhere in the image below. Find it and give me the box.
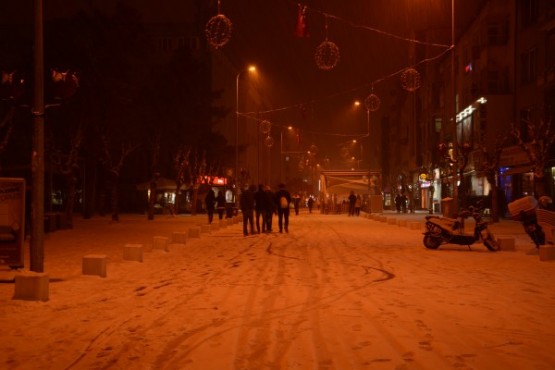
[239,184,292,236]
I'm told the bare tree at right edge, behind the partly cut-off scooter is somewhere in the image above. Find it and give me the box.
[511,119,555,198]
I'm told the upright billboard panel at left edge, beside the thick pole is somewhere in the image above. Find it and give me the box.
[0,177,25,268]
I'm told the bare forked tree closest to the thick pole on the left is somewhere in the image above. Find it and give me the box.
[49,126,83,228]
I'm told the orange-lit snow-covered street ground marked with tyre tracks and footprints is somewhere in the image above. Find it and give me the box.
[0,212,555,370]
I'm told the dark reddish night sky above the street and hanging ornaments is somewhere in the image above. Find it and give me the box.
[0,0,484,164]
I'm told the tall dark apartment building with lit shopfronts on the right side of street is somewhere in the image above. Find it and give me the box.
[390,0,555,211]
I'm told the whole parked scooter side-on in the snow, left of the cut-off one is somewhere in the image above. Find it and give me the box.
[424,207,499,252]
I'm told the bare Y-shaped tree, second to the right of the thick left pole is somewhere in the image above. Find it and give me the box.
[100,134,138,222]
